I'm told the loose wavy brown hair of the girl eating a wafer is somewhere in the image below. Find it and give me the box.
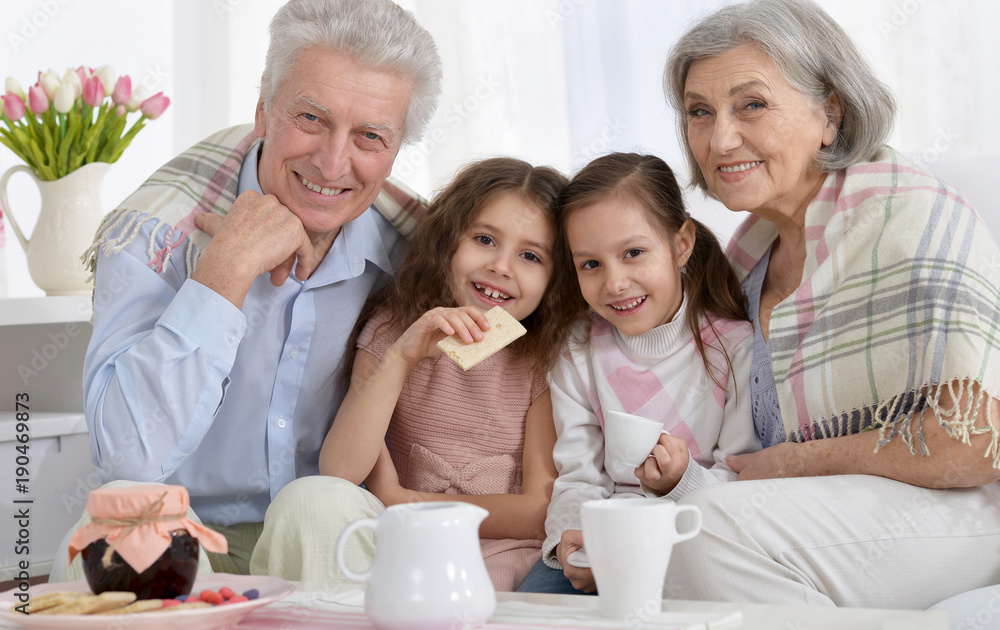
[345,157,575,386]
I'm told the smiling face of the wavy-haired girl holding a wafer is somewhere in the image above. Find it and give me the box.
[451,193,555,320]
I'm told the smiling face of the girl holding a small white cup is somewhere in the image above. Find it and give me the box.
[566,197,694,335]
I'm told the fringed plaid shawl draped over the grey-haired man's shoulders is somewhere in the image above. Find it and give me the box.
[83,125,427,277]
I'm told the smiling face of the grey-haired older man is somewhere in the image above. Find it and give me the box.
[255,48,412,242]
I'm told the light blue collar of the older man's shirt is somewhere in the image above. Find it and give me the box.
[236,139,395,285]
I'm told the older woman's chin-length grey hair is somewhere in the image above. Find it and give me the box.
[663,0,896,194]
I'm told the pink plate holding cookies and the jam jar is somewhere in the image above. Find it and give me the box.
[0,573,295,630]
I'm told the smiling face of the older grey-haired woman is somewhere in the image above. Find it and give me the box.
[684,46,839,220]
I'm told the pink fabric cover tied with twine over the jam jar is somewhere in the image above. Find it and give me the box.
[69,485,229,573]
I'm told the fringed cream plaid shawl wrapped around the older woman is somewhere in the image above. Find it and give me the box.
[728,147,1000,468]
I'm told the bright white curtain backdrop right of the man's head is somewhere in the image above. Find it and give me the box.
[396,0,1000,241]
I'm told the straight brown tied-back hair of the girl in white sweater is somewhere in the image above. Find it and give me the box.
[558,153,749,385]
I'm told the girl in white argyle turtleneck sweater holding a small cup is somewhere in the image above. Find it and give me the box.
[521,153,760,592]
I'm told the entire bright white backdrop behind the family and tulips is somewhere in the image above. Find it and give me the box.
[0,0,1000,295]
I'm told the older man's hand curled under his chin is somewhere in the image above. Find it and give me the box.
[192,190,318,308]
